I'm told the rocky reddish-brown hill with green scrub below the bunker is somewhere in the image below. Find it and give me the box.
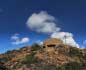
[0,44,86,70]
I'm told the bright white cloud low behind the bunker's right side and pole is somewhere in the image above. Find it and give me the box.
[51,32,79,48]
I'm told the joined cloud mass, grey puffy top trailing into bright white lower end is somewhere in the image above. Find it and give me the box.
[26,11,79,47]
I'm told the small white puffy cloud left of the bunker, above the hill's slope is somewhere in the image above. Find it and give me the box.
[11,34,30,45]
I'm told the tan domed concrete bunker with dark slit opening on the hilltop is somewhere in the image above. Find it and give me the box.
[43,38,63,52]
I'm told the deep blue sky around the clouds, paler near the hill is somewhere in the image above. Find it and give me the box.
[0,0,86,53]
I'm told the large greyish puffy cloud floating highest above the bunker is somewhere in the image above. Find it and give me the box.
[27,11,60,33]
